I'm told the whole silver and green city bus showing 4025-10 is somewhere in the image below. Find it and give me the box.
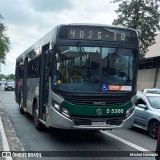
[15,23,139,130]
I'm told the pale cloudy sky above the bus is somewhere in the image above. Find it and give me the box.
[0,0,118,75]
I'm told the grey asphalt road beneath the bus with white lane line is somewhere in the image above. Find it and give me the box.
[0,86,156,160]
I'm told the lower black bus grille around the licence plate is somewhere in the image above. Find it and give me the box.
[73,117,124,126]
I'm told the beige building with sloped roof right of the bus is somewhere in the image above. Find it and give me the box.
[137,33,160,90]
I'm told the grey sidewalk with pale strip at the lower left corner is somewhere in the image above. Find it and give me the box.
[0,101,24,160]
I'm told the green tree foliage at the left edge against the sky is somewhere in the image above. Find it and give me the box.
[0,15,10,64]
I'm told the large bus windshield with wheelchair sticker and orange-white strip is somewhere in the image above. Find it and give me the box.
[52,45,138,92]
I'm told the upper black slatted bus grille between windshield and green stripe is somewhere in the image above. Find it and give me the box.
[68,95,129,106]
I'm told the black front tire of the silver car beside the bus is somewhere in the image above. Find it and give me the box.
[148,120,159,139]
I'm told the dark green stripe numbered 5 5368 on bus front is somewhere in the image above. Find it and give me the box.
[61,101,132,117]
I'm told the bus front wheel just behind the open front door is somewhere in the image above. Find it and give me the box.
[33,103,44,131]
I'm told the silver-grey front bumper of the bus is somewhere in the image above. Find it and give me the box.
[47,108,134,130]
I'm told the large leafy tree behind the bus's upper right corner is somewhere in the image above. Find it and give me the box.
[112,0,160,56]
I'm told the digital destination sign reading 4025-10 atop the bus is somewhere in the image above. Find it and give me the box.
[59,26,131,42]
